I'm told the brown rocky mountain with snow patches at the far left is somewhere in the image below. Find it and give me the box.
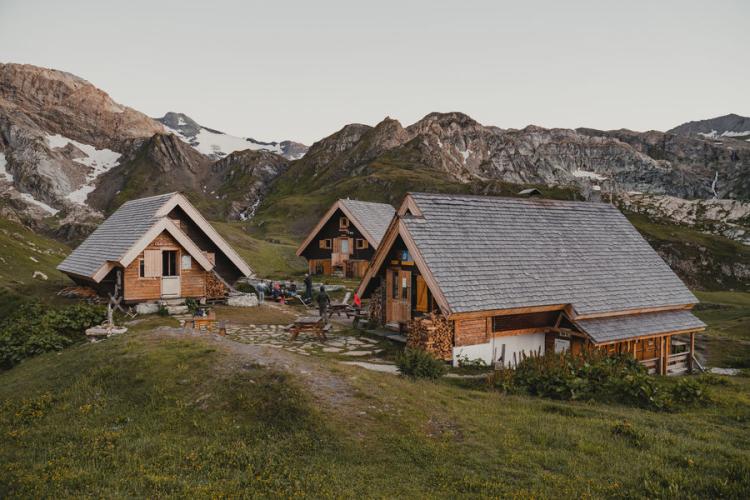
[0,64,164,221]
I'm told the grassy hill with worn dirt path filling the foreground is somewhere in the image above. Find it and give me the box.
[0,318,750,498]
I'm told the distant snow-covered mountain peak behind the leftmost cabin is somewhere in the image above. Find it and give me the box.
[156,111,307,160]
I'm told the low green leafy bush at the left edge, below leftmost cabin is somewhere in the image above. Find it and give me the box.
[0,302,106,369]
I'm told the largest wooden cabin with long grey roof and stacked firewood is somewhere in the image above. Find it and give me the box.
[358,193,705,374]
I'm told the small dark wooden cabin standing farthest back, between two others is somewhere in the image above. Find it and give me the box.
[297,199,396,278]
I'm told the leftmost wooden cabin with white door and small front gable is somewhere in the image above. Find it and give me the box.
[57,193,253,303]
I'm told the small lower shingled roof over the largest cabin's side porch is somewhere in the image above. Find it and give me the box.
[575,311,706,344]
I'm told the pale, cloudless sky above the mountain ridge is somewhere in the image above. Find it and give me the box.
[0,0,750,144]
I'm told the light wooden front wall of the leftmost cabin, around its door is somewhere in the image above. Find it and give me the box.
[123,231,206,301]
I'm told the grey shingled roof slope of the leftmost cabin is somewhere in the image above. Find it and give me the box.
[57,193,176,276]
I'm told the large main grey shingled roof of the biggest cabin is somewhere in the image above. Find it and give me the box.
[403,193,697,315]
